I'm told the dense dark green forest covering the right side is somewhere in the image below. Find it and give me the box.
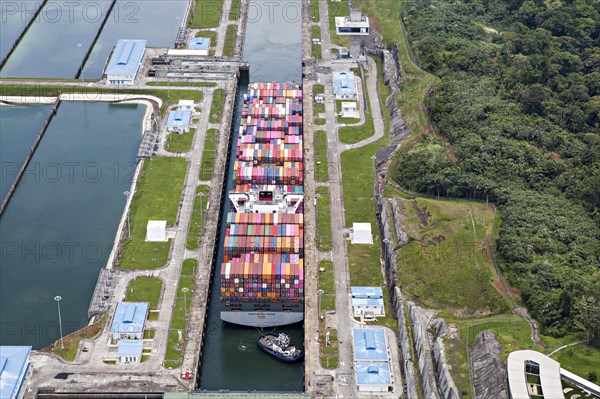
[394,0,600,345]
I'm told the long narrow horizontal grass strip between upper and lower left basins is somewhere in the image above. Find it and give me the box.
[0,82,204,115]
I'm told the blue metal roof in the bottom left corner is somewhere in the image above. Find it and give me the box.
[0,346,31,399]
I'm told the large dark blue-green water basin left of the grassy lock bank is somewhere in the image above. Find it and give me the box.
[0,102,146,349]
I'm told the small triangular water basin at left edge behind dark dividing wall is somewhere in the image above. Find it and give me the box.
[0,105,52,203]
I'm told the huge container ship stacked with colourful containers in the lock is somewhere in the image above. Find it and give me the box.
[220,83,304,327]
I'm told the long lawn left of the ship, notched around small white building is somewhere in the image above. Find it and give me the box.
[119,157,187,269]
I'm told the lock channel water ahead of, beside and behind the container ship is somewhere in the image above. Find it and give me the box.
[199,0,304,392]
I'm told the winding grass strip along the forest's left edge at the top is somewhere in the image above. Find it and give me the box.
[353,0,437,139]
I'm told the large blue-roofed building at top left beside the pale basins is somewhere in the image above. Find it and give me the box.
[104,39,146,85]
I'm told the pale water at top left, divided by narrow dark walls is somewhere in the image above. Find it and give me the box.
[0,0,188,79]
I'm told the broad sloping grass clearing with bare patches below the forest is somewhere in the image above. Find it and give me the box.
[396,198,509,318]
